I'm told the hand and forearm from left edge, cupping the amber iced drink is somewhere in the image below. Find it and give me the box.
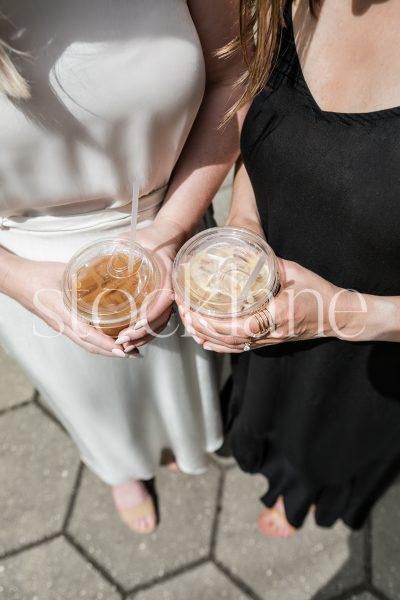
[0,251,138,358]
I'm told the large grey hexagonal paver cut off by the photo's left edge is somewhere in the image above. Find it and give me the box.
[0,405,79,554]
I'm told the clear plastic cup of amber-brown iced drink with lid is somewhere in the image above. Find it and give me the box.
[63,239,160,338]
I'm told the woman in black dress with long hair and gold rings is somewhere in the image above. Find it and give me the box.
[183,0,400,537]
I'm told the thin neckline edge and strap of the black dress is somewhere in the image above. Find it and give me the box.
[286,0,400,123]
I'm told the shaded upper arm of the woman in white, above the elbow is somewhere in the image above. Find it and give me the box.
[188,0,244,84]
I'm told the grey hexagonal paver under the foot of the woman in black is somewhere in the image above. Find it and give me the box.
[216,469,363,600]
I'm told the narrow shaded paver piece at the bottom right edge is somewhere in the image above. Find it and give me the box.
[372,483,400,599]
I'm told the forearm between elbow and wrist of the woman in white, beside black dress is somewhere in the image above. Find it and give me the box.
[156,84,244,241]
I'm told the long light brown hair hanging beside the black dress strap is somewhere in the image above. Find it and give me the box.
[222,0,321,120]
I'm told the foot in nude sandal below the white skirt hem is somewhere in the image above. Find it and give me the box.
[112,480,157,534]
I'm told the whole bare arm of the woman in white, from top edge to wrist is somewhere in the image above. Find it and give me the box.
[156,0,247,242]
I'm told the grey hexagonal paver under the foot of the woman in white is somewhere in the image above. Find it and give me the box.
[69,466,220,590]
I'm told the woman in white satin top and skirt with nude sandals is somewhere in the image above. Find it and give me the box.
[0,0,241,532]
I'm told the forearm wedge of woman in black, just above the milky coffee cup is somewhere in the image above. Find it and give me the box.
[226,160,263,235]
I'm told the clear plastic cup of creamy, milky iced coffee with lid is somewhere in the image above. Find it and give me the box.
[173,227,279,318]
